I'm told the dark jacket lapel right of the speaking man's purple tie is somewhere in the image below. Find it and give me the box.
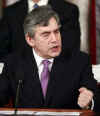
[45,58,63,106]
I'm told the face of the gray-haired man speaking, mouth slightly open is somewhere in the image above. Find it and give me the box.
[33,18,61,58]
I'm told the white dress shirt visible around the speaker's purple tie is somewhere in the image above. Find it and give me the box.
[33,49,54,80]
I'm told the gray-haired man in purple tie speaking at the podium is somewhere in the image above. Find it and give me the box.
[0,6,97,110]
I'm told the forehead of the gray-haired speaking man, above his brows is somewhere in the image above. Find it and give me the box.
[36,18,59,32]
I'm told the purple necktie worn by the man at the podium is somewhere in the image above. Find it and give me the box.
[41,60,50,97]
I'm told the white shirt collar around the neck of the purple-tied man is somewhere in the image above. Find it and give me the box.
[33,49,54,67]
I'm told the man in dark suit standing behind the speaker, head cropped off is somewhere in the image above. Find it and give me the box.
[0,0,80,61]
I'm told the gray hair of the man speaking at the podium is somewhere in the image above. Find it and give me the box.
[23,5,60,38]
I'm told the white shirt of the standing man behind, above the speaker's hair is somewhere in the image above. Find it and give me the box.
[28,0,48,12]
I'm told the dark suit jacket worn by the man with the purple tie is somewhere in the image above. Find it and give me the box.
[0,48,96,109]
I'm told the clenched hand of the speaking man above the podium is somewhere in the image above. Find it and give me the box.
[78,87,93,108]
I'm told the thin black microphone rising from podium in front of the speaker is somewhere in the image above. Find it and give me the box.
[14,80,23,116]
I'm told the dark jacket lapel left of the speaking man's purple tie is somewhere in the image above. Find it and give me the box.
[23,50,43,101]
